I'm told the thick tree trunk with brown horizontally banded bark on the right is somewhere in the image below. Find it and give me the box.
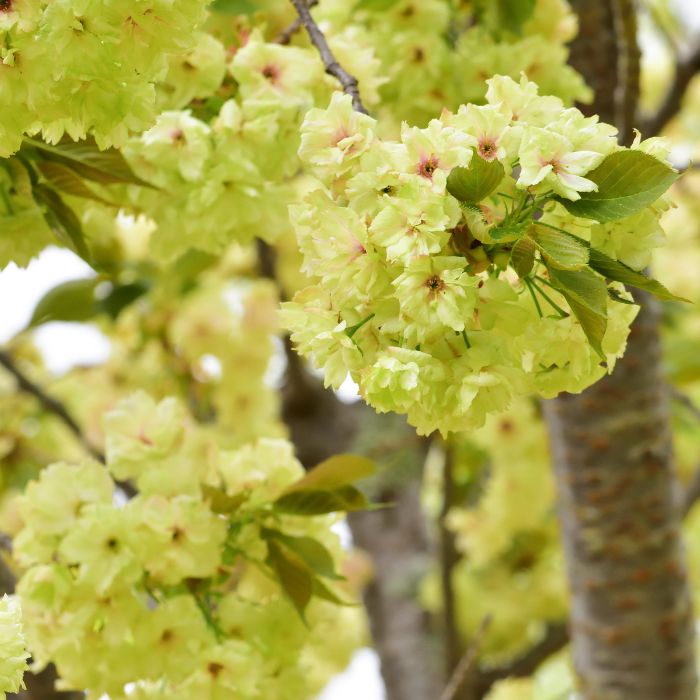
[545,0,696,700]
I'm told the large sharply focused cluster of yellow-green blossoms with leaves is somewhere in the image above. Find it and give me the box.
[282,76,676,433]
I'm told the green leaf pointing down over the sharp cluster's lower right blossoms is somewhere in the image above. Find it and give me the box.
[547,267,608,360]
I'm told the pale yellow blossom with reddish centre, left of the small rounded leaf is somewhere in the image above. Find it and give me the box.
[386,119,476,193]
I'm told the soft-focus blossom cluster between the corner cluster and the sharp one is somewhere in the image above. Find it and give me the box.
[121,31,377,259]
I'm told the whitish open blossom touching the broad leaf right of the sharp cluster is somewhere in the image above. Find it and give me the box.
[518,128,604,200]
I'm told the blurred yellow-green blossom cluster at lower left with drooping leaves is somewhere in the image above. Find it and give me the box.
[15,392,362,700]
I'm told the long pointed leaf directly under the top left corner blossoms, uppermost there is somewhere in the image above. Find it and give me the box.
[24,136,157,189]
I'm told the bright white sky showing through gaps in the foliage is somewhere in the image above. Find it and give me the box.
[0,0,700,700]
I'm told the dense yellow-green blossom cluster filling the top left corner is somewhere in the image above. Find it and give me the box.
[0,0,205,158]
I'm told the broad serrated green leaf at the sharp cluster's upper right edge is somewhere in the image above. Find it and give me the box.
[554,151,681,223]
